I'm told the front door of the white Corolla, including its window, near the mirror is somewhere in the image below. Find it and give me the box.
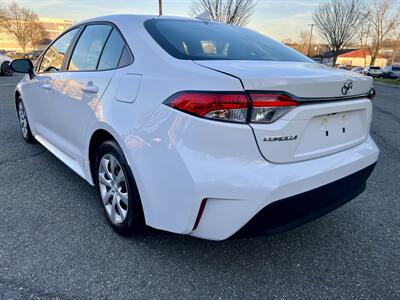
[23,28,79,139]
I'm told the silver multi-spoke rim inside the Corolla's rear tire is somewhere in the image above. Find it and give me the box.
[98,154,129,224]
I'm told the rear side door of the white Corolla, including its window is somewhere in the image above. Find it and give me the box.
[50,24,125,165]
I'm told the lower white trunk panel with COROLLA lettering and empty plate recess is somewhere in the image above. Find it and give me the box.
[251,99,372,163]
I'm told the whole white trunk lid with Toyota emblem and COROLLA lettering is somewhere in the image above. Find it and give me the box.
[196,61,372,163]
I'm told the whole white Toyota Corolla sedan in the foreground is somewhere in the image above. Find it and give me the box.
[12,15,379,240]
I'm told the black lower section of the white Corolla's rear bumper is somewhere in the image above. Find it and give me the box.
[237,163,376,236]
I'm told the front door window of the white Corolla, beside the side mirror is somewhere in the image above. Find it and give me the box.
[39,28,78,73]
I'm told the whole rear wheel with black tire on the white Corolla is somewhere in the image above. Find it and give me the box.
[94,141,145,236]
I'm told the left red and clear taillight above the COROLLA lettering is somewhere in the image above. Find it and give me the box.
[164,92,298,123]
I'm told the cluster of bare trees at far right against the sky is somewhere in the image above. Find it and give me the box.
[313,0,400,65]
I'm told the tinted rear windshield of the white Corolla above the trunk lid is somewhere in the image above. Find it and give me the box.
[145,19,314,62]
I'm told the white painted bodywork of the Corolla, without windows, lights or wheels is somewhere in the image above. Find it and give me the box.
[17,15,379,240]
